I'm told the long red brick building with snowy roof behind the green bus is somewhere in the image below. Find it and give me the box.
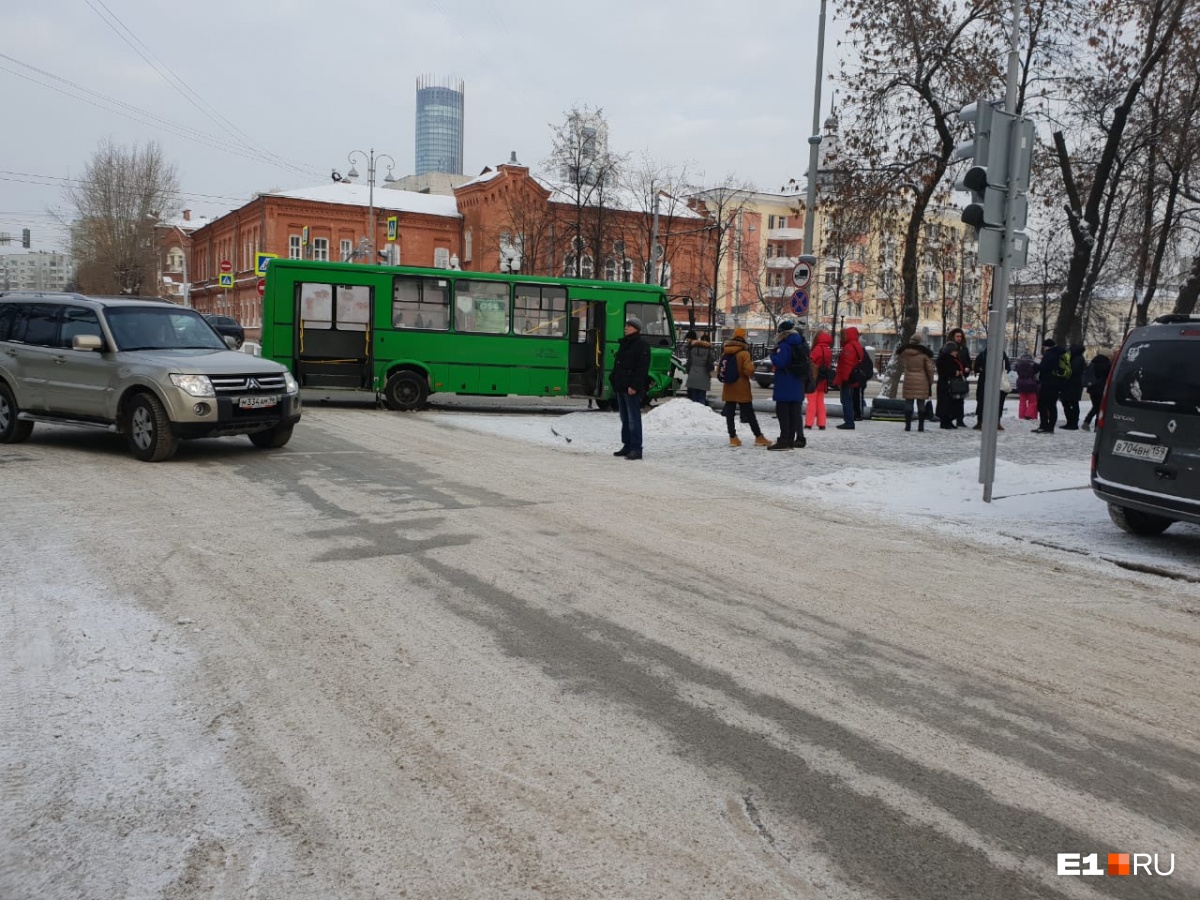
[180,163,715,337]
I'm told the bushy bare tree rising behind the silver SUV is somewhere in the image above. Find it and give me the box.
[66,140,180,295]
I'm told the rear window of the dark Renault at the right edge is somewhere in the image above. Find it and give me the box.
[1112,341,1200,415]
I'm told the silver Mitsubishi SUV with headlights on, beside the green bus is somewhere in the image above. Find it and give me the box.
[0,292,300,462]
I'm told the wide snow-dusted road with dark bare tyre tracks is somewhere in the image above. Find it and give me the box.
[0,408,1200,900]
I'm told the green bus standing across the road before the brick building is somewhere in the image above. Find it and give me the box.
[260,259,678,410]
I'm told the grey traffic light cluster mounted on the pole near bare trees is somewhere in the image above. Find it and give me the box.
[954,101,1033,269]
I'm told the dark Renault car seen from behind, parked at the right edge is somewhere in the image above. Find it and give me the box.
[1092,314,1200,535]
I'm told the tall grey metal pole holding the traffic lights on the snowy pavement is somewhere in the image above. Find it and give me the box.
[979,0,1021,503]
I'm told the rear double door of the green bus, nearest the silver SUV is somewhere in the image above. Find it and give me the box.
[295,282,373,389]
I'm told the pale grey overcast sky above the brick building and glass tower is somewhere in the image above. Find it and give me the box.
[0,0,841,250]
